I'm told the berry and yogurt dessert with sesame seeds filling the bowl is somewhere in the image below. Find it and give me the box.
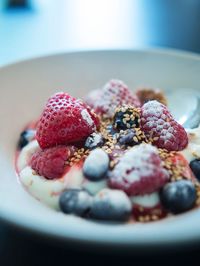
[16,80,200,222]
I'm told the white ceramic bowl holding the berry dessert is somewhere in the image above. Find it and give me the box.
[0,50,200,247]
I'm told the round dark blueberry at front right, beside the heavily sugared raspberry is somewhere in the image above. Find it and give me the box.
[160,180,196,214]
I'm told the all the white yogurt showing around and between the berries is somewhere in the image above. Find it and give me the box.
[17,123,200,209]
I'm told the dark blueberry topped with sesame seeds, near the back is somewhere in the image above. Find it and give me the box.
[114,105,140,130]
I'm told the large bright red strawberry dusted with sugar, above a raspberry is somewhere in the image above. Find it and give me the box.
[36,92,99,149]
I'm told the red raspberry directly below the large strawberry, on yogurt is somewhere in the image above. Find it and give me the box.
[29,145,76,179]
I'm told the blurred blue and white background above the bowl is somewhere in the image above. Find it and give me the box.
[0,0,200,65]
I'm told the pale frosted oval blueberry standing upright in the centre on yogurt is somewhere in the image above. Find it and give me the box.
[83,149,109,181]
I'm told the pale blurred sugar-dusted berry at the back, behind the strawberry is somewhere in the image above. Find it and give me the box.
[86,79,140,118]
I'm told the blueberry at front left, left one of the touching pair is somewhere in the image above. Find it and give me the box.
[59,189,92,217]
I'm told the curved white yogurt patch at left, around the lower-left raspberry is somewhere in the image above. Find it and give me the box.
[17,140,107,209]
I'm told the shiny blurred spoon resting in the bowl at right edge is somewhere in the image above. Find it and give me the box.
[167,89,200,129]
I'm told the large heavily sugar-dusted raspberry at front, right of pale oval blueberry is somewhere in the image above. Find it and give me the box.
[109,144,169,195]
